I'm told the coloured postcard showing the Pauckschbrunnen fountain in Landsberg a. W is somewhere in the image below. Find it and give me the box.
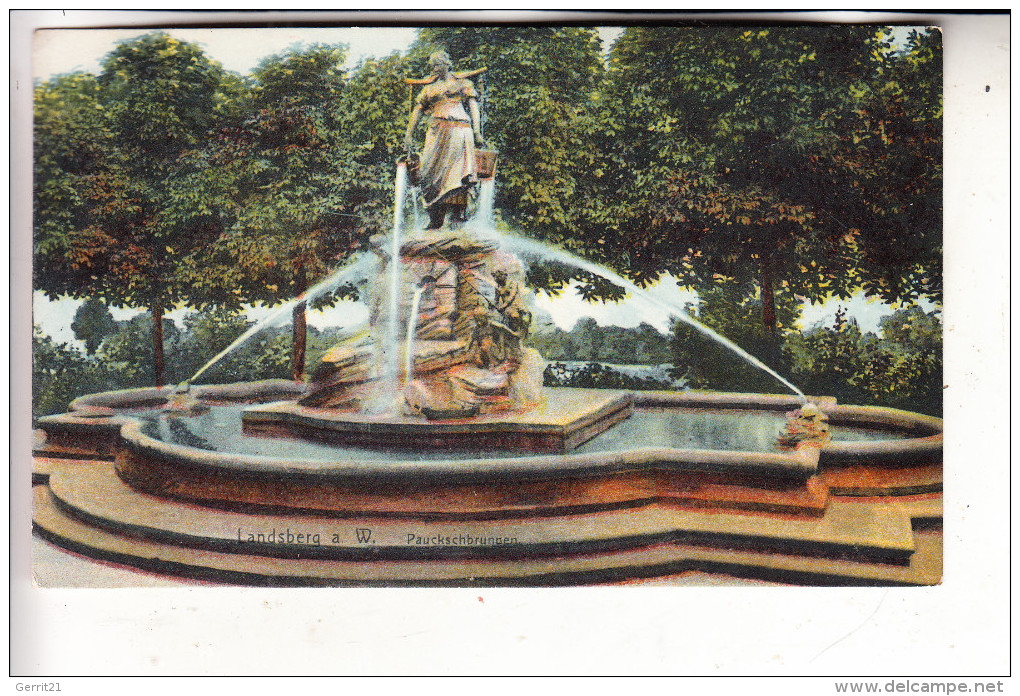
[11,10,1007,681]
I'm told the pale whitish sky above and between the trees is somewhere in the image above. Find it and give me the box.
[32,27,931,345]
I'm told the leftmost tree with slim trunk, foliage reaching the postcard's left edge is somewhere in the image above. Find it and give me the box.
[35,33,233,385]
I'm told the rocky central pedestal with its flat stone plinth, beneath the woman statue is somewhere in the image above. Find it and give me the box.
[244,222,631,452]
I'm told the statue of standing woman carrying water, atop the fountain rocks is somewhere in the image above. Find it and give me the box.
[404,51,485,230]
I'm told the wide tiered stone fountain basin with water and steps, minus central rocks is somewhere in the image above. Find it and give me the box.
[33,381,941,587]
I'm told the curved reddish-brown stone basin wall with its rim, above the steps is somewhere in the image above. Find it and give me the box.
[33,381,941,518]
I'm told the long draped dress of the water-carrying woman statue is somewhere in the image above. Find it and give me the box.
[417,79,478,207]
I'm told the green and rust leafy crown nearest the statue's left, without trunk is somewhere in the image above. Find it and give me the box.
[173,45,347,308]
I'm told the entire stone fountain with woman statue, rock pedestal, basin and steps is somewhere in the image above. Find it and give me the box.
[33,55,942,586]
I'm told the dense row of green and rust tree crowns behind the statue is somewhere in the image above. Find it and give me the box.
[34,26,942,395]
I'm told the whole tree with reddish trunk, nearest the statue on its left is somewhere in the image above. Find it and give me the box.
[177,45,387,380]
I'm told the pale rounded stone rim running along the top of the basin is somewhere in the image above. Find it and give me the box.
[38,380,942,473]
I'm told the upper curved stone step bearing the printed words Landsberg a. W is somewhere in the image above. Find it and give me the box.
[49,462,914,564]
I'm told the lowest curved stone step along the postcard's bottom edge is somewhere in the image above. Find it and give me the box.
[34,486,941,587]
